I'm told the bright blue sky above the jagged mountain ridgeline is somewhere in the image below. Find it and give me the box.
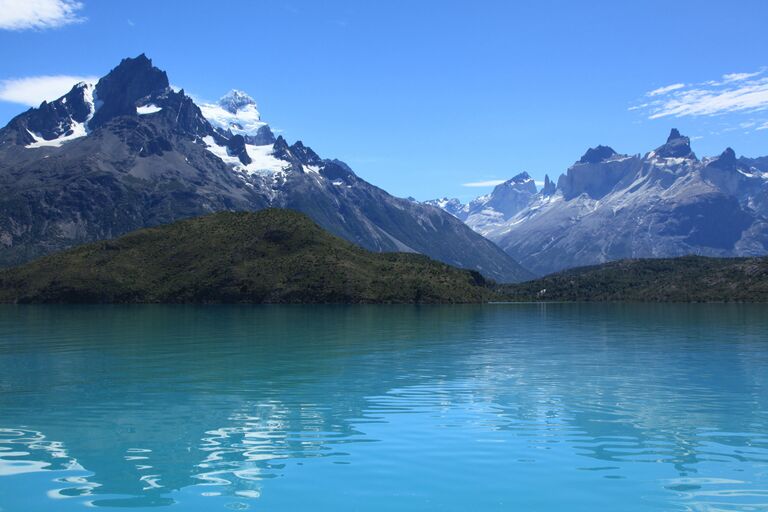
[0,0,768,200]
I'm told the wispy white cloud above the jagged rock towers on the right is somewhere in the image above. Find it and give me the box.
[630,69,768,119]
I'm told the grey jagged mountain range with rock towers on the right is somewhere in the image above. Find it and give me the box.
[428,129,768,275]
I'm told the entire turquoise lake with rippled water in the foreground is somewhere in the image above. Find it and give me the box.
[0,304,768,512]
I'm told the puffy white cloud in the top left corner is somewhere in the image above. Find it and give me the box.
[0,0,83,30]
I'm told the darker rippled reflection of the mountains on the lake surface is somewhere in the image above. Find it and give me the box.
[0,305,768,506]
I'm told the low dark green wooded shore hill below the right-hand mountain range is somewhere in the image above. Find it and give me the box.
[501,256,768,302]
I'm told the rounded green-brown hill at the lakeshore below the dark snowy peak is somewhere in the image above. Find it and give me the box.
[0,209,493,303]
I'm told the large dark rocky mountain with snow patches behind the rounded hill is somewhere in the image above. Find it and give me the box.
[0,55,530,281]
